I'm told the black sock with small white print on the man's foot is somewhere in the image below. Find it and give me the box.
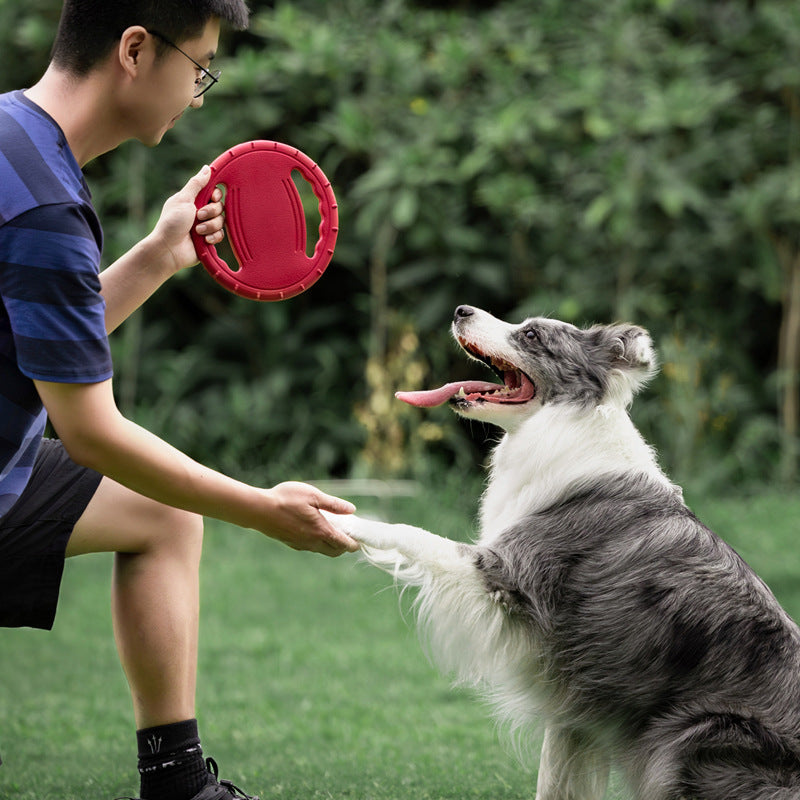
[136,719,208,800]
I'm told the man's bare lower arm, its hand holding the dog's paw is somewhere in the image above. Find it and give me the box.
[36,380,358,555]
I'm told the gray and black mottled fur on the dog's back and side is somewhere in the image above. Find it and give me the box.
[482,475,800,800]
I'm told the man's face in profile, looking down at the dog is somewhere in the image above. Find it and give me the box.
[136,18,219,146]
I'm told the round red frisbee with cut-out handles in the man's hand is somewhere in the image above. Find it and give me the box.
[192,141,339,300]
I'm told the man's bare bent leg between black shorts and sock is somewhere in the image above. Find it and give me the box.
[67,478,203,729]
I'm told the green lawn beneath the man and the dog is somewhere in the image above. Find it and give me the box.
[0,482,800,800]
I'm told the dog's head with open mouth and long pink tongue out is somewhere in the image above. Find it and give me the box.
[397,306,657,429]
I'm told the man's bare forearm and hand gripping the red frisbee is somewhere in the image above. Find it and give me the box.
[100,167,224,333]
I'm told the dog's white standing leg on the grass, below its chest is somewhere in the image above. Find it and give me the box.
[536,727,609,800]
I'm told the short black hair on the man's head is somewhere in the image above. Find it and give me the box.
[52,0,249,76]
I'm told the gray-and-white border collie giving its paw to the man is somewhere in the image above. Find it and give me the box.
[329,306,800,800]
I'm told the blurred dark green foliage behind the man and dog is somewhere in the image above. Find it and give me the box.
[0,0,800,487]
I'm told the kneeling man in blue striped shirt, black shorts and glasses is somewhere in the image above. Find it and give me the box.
[0,0,356,800]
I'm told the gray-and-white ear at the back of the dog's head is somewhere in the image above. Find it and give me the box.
[595,324,658,405]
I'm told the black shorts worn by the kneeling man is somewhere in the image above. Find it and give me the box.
[0,439,103,630]
